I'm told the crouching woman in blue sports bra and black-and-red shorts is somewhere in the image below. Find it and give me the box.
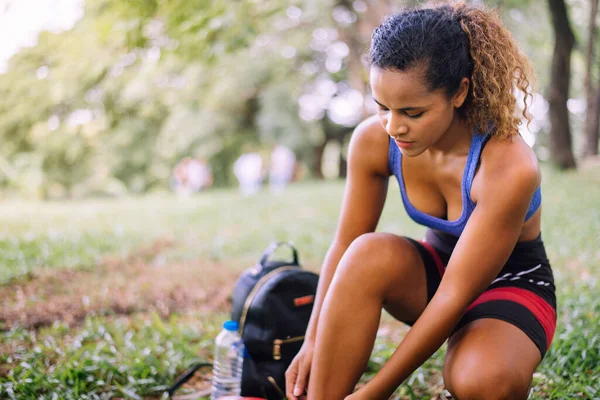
[286,4,556,400]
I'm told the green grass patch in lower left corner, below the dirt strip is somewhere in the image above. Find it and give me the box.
[0,314,223,400]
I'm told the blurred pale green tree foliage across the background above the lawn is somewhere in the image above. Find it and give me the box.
[0,0,587,198]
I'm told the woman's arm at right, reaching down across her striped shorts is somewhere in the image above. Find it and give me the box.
[349,143,539,399]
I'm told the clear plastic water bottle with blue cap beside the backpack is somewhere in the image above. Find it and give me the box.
[210,321,244,400]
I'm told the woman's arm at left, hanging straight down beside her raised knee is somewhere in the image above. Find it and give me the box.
[286,117,389,399]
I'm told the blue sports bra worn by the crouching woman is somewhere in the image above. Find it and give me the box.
[388,133,542,236]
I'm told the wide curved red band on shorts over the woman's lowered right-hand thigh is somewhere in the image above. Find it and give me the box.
[467,287,556,348]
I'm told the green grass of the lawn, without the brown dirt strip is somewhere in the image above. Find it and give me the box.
[0,164,600,399]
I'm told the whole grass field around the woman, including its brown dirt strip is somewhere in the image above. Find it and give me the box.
[0,164,600,399]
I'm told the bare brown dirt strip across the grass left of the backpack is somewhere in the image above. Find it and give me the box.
[0,240,238,329]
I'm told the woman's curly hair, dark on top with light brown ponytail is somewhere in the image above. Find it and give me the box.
[369,2,534,138]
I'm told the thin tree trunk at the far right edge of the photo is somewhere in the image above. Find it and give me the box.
[582,0,600,157]
